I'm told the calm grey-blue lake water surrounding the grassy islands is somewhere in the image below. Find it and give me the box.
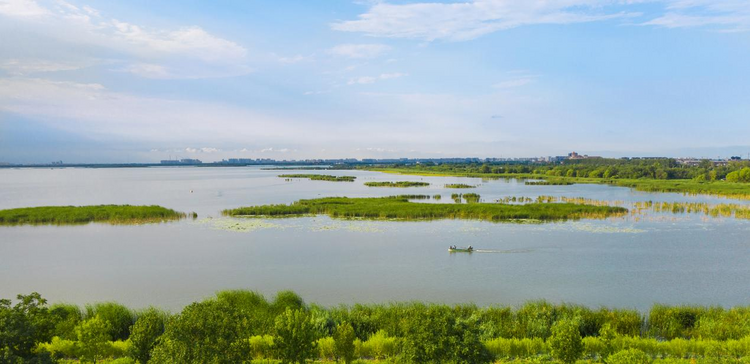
[0,167,750,311]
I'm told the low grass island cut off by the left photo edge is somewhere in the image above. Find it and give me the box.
[0,205,191,225]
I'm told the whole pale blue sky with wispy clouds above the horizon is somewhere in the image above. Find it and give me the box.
[0,0,750,163]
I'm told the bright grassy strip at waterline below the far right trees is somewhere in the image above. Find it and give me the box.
[371,168,750,199]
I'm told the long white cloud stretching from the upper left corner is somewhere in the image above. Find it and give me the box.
[0,0,252,78]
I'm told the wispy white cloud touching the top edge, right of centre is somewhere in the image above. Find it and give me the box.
[331,0,629,41]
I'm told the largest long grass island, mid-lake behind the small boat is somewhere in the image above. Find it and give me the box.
[223,196,628,222]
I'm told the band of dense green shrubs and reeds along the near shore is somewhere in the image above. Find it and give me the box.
[0,290,750,364]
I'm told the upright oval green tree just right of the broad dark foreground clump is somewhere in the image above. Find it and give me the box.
[274,308,317,364]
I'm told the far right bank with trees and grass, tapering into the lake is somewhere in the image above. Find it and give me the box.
[368,158,750,199]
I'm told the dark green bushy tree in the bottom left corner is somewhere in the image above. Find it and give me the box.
[0,292,54,362]
